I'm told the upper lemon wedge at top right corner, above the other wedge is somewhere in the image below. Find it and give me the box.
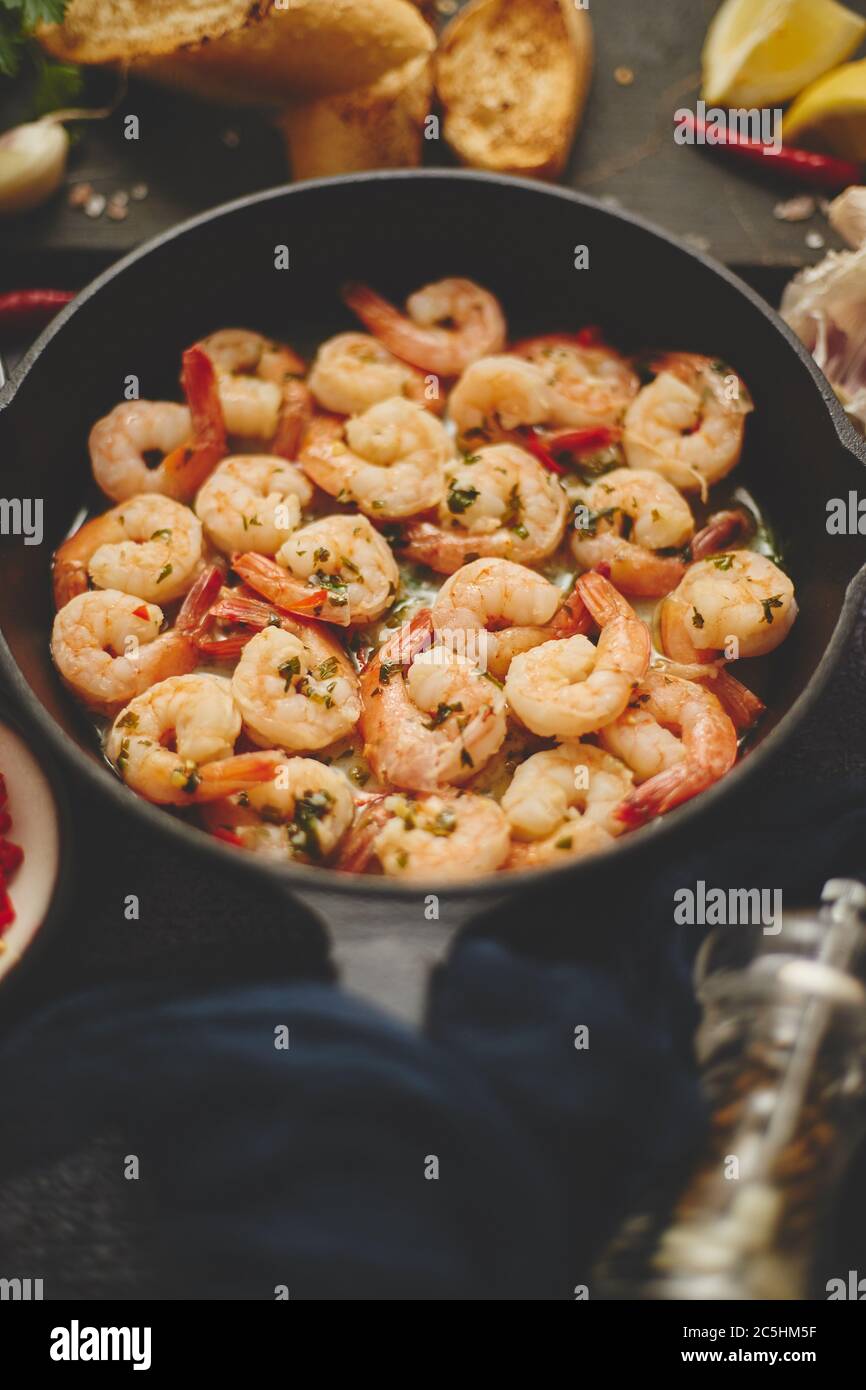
[702,0,866,106]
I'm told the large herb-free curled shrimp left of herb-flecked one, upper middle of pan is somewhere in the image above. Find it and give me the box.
[299,396,455,521]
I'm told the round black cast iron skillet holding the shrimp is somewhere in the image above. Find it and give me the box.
[0,171,866,1015]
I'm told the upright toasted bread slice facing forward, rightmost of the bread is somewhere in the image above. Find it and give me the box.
[436,0,592,178]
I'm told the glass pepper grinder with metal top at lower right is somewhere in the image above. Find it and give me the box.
[599,878,866,1300]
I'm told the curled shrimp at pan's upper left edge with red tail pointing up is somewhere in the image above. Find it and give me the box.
[89,348,227,502]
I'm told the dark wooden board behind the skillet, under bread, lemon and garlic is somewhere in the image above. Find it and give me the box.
[0,0,866,289]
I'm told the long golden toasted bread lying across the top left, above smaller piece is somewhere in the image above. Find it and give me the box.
[40,0,435,106]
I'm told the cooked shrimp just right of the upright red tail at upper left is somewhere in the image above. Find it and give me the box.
[197,328,311,459]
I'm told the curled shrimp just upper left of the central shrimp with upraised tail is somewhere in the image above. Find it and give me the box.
[431,559,589,680]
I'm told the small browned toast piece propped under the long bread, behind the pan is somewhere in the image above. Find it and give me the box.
[278,54,432,179]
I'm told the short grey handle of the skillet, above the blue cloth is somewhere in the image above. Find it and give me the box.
[288,888,505,1027]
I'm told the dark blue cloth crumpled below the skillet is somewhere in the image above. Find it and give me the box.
[0,781,866,1300]
